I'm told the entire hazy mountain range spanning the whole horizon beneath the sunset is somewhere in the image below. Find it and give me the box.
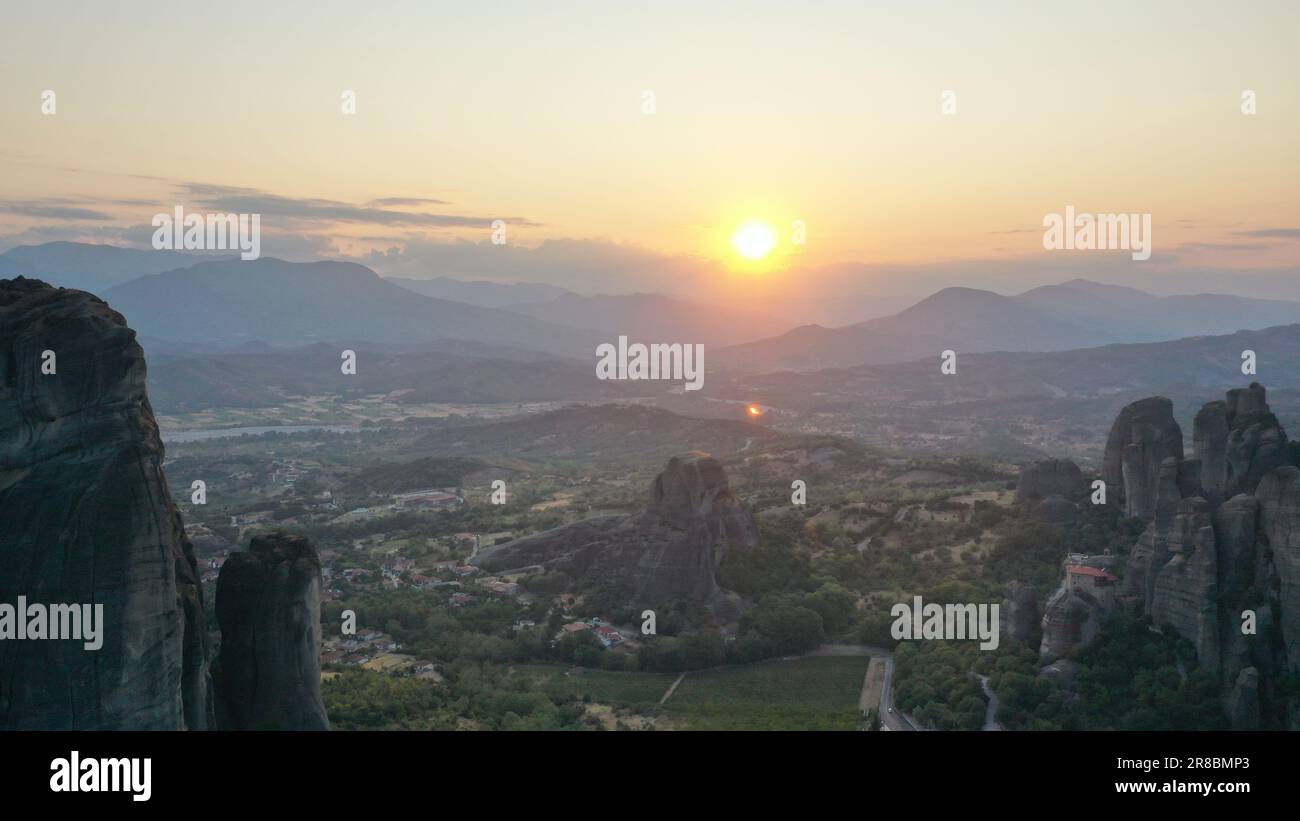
[0,243,1300,373]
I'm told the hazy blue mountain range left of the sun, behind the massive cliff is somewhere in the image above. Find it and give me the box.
[0,243,789,360]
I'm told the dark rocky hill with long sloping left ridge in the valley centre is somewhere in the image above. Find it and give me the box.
[473,452,758,621]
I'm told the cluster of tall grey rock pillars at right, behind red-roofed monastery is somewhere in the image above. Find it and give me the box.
[1043,383,1300,729]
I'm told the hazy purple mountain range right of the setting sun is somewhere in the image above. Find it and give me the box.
[711,279,1300,372]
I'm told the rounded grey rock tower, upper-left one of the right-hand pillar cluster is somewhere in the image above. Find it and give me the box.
[1101,396,1183,518]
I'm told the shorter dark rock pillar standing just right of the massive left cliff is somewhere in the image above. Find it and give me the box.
[213,533,329,730]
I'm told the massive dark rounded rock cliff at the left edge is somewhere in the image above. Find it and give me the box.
[0,277,212,730]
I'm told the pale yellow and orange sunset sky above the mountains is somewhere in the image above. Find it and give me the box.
[0,1,1300,301]
